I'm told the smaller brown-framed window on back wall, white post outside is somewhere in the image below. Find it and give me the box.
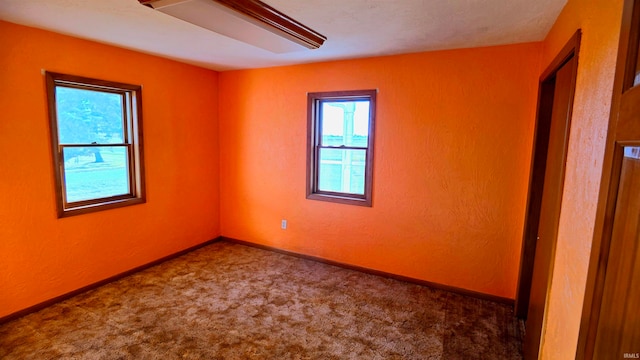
[307,90,376,206]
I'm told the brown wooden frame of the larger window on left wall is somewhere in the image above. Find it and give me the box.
[45,71,146,218]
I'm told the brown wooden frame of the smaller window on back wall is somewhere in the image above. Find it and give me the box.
[307,90,377,207]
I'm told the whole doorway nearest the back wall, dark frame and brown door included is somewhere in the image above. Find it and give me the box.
[515,30,581,359]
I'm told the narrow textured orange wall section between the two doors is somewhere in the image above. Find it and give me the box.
[541,0,622,359]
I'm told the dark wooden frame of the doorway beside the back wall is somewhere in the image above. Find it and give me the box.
[515,29,582,319]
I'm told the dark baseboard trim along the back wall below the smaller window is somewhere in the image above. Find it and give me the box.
[220,236,515,306]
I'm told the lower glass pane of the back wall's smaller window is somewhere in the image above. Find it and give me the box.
[318,149,367,195]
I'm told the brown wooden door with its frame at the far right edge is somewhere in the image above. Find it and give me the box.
[578,0,640,359]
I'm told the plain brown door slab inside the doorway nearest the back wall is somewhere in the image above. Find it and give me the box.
[524,56,577,359]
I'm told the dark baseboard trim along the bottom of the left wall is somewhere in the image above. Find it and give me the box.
[0,236,223,324]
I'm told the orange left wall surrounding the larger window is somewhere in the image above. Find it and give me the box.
[0,22,220,317]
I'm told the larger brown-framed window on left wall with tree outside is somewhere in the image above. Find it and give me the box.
[45,72,145,217]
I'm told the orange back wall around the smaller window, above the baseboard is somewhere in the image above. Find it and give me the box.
[219,43,541,298]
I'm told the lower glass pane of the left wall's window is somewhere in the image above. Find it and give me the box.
[63,146,129,202]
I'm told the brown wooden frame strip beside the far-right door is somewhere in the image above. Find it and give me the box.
[576,0,640,360]
